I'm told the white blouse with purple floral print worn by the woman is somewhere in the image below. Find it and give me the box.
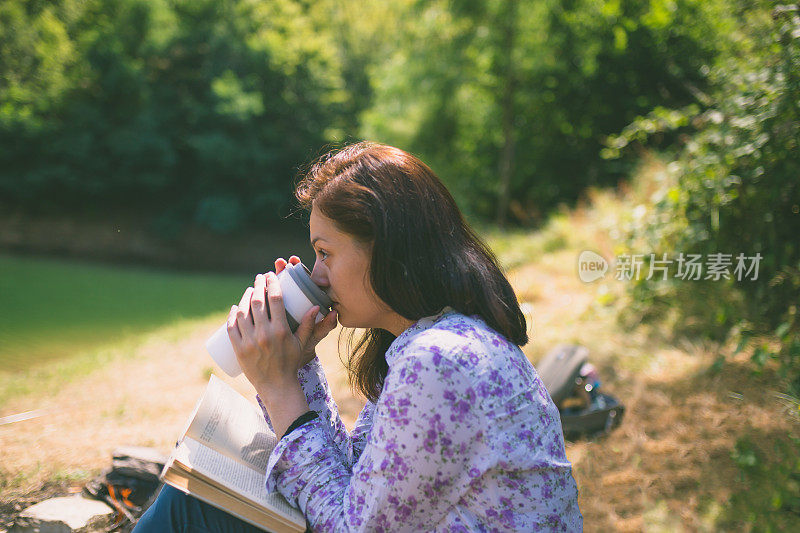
[262,310,583,532]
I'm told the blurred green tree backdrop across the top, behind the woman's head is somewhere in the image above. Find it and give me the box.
[0,0,776,231]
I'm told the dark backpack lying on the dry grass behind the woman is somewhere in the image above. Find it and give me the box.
[536,344,625,439]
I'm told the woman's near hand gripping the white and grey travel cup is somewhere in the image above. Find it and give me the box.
[228,256,336,390]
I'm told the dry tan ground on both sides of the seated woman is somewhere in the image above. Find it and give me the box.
[0,247,798,531]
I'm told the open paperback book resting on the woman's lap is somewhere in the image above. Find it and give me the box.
[161,375,306,533]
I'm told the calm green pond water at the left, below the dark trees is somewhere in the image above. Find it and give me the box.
[0,255,253,372]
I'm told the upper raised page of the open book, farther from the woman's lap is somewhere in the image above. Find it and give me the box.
[185,374,278,475]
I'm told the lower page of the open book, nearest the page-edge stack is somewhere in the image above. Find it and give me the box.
[172,438,304,521]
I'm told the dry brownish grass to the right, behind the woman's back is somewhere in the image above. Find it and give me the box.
[506,161,800,531]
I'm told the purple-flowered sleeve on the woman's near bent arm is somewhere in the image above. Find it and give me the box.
[266,351,484,531]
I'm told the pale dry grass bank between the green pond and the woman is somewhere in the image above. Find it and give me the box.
[0,316,363,503]
